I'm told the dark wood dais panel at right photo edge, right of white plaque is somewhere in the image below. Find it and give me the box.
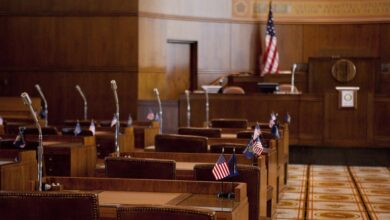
[372,95,390,146]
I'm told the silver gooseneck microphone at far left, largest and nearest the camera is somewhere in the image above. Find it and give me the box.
[20,92,43,191]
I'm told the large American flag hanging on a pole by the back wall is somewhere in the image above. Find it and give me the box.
[261,1,279,75]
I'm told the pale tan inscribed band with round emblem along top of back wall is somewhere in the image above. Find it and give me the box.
[232,0,390,23]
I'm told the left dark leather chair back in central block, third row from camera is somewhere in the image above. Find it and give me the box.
[154,134,207,153]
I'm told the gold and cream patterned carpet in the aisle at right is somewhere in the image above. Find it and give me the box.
[274,165,390,220]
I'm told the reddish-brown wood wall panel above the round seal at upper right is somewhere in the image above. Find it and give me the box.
[302,24,380,61]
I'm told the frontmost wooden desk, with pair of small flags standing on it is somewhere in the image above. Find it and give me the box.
[45,177,248,220]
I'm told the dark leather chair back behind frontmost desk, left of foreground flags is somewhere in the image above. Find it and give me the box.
[105,157,176,179]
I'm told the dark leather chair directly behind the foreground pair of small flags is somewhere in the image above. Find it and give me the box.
[194,164,260,220]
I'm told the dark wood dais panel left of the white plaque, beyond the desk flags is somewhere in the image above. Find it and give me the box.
[298,95,325,145]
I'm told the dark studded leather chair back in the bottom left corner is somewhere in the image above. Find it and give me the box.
[0,191,99,220]
